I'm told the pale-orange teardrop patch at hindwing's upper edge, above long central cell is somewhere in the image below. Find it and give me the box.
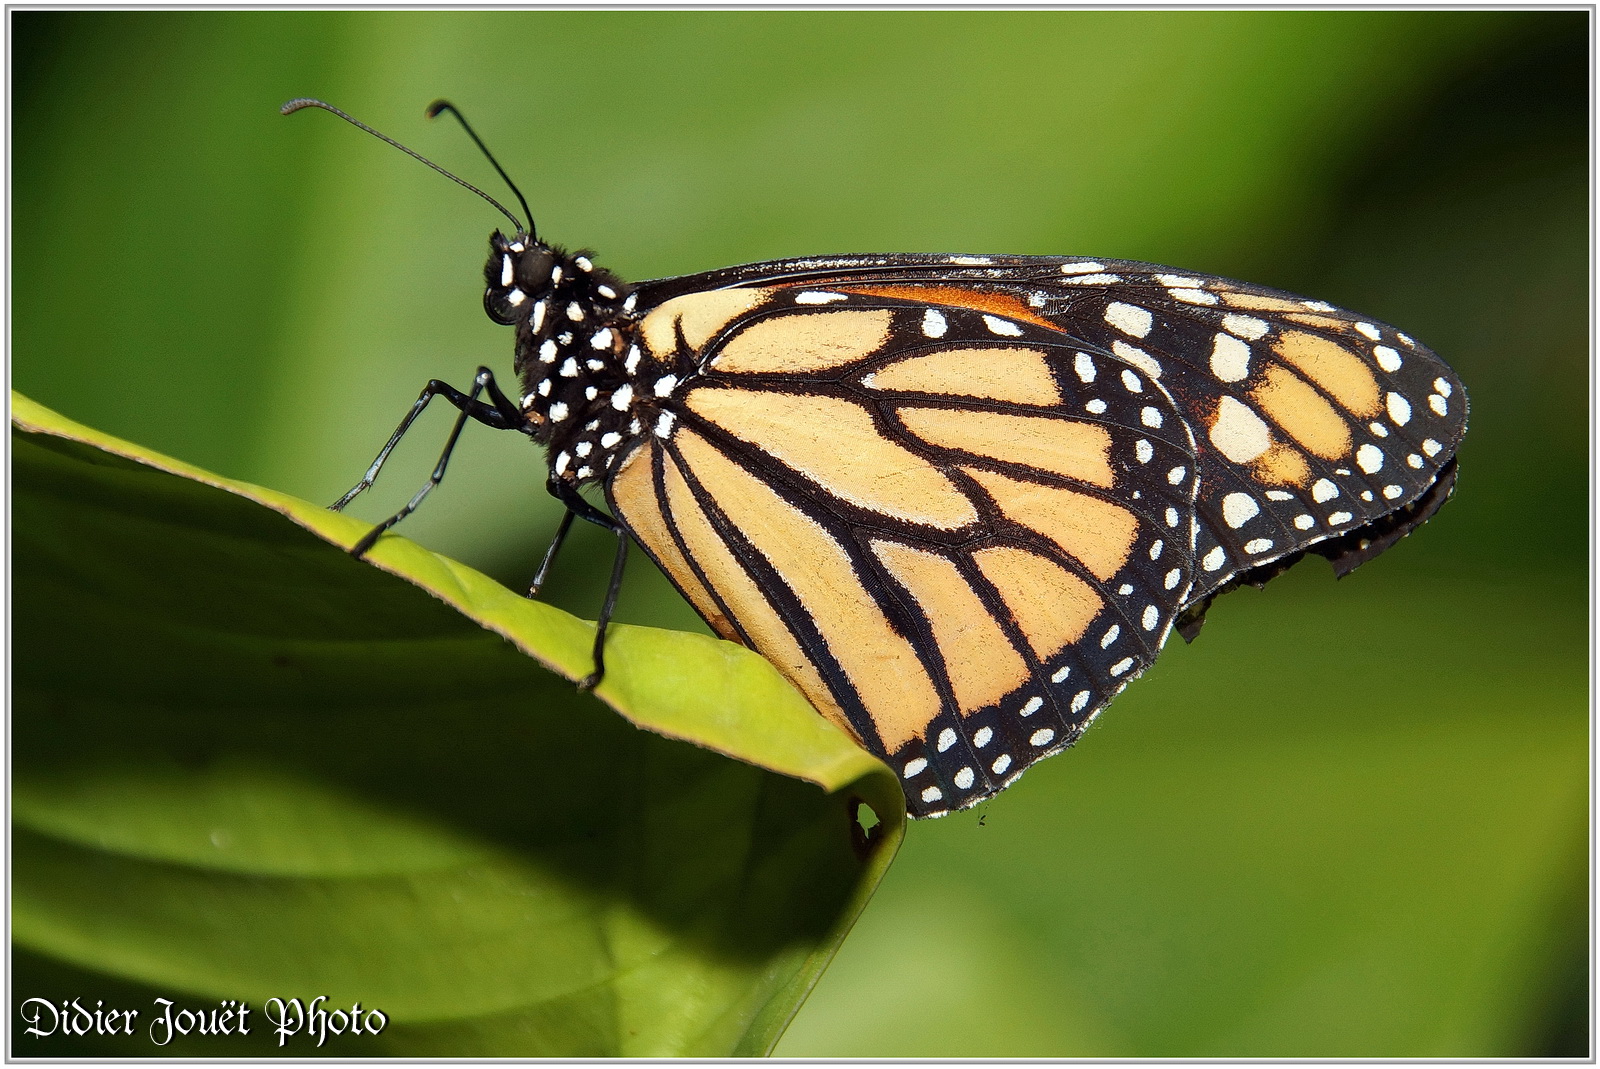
[710,309,893,374]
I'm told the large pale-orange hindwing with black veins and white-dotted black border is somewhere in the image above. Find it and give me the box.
[611,286,1197,816]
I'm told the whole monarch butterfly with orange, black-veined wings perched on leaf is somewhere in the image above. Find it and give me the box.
[283,99,1467,816]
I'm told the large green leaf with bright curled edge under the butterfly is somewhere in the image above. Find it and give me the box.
[11,388,904,1056]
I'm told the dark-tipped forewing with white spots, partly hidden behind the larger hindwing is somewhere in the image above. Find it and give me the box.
[633,256,1467,603]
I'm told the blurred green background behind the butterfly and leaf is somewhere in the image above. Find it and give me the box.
[11,11,1590,1058]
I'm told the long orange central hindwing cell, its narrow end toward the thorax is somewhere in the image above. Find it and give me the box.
[685,386,978,531]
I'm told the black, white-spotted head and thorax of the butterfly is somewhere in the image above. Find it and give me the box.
[483,230,654,483]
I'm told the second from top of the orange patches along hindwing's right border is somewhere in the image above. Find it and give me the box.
[896,405,1114,488]
